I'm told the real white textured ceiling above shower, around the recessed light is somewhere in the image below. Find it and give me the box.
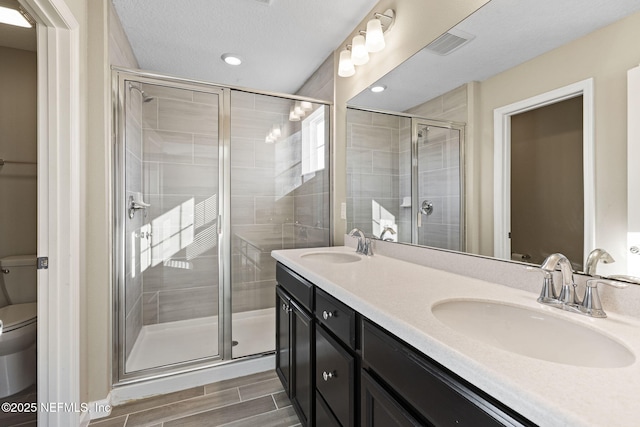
[113,0,377,93]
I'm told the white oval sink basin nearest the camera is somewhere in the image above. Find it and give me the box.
[431,300,635,368]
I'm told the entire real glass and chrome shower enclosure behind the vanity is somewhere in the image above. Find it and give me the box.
[113,69,331,383]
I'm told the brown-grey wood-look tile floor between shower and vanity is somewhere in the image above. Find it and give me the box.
[89,371,300,427]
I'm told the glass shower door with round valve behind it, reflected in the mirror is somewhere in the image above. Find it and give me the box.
[412,119,464,251]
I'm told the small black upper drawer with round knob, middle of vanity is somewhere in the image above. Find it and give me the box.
[315,288,356,350]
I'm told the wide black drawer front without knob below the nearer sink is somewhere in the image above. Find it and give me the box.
[362,320,533,427]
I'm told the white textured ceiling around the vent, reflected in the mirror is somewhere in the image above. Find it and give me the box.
[349,0,640,111]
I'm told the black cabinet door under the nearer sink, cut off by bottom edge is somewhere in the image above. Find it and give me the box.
[360,370,425,427]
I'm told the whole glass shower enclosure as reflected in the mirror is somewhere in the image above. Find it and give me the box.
[347,107,464,251]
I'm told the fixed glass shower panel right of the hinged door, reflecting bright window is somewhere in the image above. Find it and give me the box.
[231,91,329,358]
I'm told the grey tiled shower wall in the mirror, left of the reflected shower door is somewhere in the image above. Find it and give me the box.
[347,109,411,241]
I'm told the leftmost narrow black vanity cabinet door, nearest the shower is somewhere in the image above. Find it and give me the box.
[276,286,291,397]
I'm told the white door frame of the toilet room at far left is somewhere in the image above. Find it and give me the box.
[20,0,81,426]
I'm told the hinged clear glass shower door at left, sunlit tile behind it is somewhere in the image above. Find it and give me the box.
[118,78,223,377]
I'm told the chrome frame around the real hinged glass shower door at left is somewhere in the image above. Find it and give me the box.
[112,68,231,385]
